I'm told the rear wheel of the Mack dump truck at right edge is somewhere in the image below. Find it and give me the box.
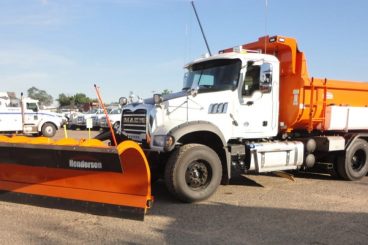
[337,139,368,180]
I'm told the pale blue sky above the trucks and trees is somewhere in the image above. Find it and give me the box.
[0,0,368,102]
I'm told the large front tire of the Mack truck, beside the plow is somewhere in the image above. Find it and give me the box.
[165,144,222,203]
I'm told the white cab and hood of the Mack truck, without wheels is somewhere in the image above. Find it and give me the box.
[122,53,279,147]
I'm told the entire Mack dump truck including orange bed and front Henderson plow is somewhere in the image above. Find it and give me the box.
[0,36,368,220]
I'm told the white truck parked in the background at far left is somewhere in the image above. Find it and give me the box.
[0,98,67,137]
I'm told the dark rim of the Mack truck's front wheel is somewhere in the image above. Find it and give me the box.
[185,160,212,190]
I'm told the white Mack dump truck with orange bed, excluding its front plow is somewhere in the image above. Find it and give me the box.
[120,36,368,202]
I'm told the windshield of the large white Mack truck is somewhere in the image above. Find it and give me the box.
[183,59,241,90]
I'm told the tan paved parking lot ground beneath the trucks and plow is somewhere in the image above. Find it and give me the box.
[0,130,368,244]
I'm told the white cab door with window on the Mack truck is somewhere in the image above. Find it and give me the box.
[236,61,278,138]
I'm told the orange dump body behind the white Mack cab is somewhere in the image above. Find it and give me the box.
[225,36,368,132]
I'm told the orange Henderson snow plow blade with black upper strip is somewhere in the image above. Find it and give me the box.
[0,136,153,220]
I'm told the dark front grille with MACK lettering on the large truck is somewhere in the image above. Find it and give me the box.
[121,109,147,135]
